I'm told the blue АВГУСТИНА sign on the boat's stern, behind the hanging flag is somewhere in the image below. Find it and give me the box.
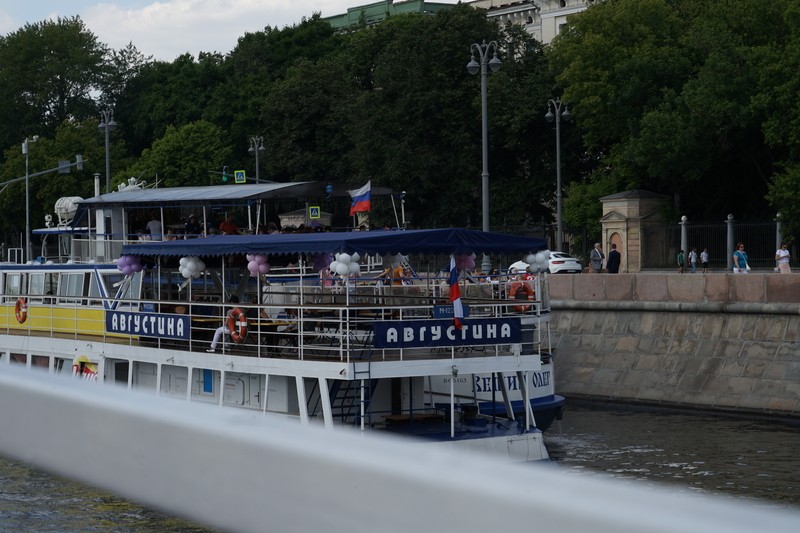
[373,318,521,348]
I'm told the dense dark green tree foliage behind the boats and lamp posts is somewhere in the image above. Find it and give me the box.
[0,0,800,249]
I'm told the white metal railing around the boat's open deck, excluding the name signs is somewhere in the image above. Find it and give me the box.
[0,278,549,362]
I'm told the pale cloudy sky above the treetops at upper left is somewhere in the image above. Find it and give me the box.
[0,0,457,61]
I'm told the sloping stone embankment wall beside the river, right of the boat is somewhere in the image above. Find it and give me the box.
[549,273,800,418]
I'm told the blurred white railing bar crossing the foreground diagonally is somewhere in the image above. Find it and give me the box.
[0,367,800,533]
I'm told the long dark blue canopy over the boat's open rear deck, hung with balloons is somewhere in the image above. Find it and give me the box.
[122,228,547,257]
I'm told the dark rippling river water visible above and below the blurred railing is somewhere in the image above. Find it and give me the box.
[0,404,800,533]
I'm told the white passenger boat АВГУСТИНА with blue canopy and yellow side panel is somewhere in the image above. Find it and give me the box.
[0,186,563,460]
